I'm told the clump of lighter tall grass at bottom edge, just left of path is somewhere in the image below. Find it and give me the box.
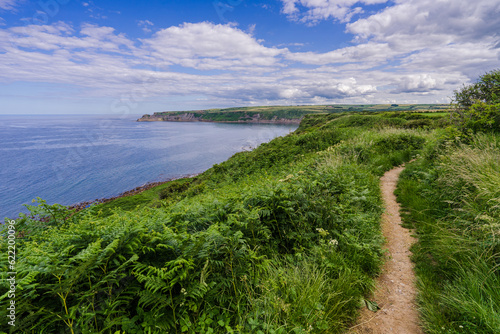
[246,258,359,333]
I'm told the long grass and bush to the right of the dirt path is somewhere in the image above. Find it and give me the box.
[398,71,500,334]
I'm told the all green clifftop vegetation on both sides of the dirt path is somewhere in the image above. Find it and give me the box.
[0,68,500,334]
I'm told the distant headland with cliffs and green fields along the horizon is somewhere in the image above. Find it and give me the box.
[137,104,449,124]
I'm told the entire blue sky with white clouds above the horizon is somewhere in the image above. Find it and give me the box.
[0,0,500,115]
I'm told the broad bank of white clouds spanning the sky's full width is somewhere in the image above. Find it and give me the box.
[0,0,500,105]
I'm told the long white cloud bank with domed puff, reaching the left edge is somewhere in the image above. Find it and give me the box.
[0,23,377,105]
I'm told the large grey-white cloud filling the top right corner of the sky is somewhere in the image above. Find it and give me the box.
[347,0,500,77]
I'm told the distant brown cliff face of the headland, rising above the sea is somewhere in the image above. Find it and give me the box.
[137,113,302,124]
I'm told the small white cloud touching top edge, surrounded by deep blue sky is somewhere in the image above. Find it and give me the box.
[281,0,388,24]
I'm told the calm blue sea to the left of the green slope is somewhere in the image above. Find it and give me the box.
[0,115,297,222]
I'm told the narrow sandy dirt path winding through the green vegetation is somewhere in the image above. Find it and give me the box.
[349,167,423,334]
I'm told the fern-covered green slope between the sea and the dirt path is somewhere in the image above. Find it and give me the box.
[0,113,450,333]
